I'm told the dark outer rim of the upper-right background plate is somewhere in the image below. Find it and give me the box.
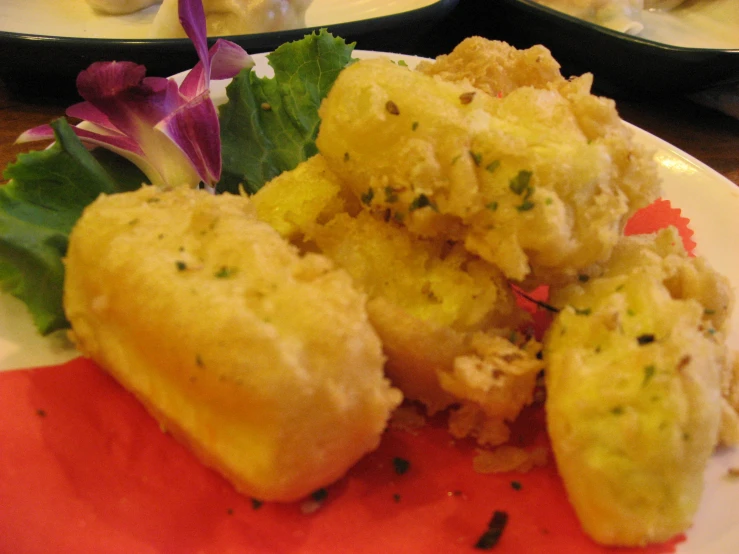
[429,0,739,97]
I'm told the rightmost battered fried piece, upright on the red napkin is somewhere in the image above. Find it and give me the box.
[544,229,732,545]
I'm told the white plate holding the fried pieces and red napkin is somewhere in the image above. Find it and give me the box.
[0,51,739,554]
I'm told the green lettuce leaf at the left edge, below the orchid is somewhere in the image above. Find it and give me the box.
[0,119,143,335]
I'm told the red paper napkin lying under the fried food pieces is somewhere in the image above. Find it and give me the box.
[0,199,690,554]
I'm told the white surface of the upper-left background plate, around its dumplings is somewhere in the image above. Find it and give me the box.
[0,0,446,39]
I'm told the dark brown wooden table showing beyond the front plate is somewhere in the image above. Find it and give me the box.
[0,75,739,186]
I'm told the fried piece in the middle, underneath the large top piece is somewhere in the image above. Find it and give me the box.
[253,154,542,444]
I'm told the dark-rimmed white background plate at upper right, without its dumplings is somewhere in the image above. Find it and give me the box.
[498,0,739,98]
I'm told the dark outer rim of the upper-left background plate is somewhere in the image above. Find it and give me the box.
[0,0,460,98]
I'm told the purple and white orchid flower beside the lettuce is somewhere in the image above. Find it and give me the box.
[17,0,254,190]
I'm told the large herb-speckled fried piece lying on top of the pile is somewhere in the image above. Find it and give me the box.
[317,55,659,285]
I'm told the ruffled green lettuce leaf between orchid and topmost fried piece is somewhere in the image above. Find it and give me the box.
[217,30,354,194]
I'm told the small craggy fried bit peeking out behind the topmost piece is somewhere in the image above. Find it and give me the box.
[417,37,564,97]
